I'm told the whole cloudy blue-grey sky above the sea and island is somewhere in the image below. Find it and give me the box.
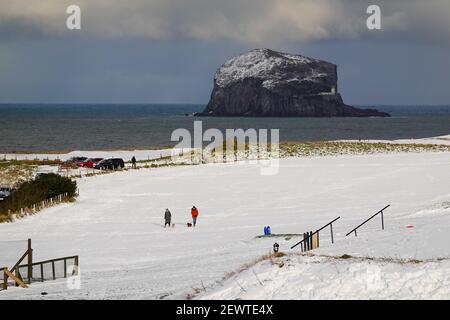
[0,0,450,106]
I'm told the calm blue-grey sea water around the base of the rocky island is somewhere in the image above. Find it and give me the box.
[0,104,450,152]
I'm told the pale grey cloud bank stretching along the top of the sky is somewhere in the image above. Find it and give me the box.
[0,0,450,44]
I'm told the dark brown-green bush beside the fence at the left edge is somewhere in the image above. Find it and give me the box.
[0,173,77,216]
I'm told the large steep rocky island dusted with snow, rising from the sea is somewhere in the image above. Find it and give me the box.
[196,49,390,117]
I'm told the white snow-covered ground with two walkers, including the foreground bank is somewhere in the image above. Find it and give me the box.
[0,152,450,299]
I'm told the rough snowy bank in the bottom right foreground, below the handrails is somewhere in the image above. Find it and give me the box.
[201,256,450,300]
